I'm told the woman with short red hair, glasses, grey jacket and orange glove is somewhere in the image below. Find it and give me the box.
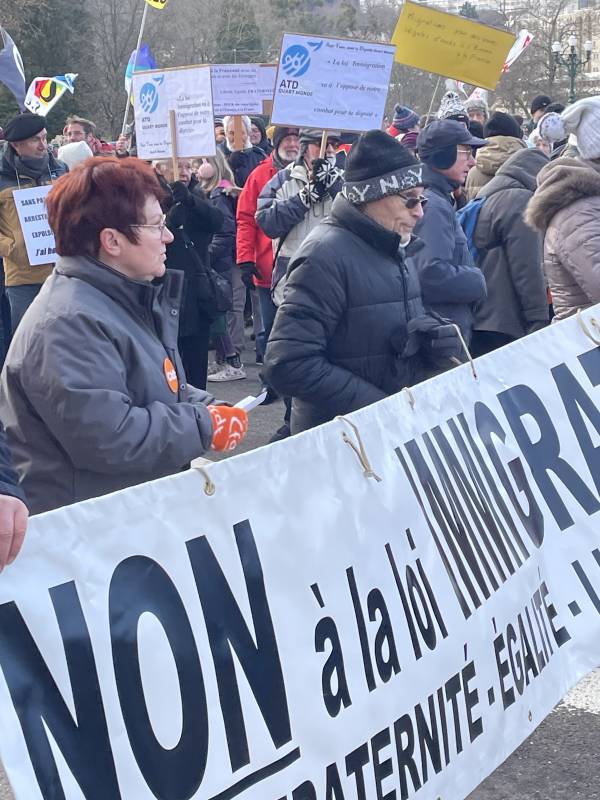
[0,158,247,513]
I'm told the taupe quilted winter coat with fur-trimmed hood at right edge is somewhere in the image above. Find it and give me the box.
[526,158,600,320]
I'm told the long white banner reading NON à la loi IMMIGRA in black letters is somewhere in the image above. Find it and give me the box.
[0,306,600,800]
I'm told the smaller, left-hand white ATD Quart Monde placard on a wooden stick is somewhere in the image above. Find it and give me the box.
[133,66,216,159]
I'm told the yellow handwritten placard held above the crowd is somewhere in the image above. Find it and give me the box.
[392,0,516,89]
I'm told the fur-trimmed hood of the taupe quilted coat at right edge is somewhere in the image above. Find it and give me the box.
[525,158,600,232]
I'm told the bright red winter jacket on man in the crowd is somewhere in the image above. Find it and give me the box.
[236,153,279,289]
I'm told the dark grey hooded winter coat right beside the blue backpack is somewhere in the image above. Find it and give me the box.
[473,149,549,339]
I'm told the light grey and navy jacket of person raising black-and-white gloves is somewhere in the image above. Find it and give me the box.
[256,161,343,305]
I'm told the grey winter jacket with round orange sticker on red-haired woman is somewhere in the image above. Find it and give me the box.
[0,257,212,514]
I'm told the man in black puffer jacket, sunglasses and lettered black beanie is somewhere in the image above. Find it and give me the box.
[265,131,460,433]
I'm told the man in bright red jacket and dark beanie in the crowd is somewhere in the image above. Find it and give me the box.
[232,126,300,363]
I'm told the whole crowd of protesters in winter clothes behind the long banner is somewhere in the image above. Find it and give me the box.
[0,91,600,567]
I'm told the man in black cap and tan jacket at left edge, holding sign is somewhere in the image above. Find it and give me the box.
[0,113,68,332]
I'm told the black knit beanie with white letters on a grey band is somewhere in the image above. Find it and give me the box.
[342,130,423,204]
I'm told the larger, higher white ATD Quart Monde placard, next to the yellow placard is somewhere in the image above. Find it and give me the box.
[271,33,396,131]
